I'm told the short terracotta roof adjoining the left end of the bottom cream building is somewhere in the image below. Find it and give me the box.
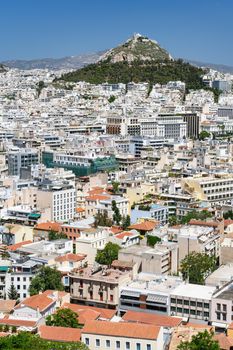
[39,326,81,342]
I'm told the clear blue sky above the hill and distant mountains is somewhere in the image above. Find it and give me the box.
[0,0,233,66]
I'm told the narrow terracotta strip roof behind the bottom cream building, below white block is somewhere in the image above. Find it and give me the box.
[122,311,182,327]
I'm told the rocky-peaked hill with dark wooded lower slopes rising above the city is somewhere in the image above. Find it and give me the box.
[57,34,205,89]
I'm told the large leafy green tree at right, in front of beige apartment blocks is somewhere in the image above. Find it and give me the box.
[180,252,217,284]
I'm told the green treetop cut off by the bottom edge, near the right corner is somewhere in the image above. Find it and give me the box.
[177,330,220,350]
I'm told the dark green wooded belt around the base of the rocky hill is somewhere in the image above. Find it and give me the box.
[59,60,205,89]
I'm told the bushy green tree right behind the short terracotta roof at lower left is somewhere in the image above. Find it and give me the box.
[46,309,81,328]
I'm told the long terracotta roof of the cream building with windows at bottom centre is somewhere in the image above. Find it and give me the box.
[82,321,160,340]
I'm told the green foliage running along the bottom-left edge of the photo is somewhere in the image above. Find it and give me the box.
[0,332,88,350]
